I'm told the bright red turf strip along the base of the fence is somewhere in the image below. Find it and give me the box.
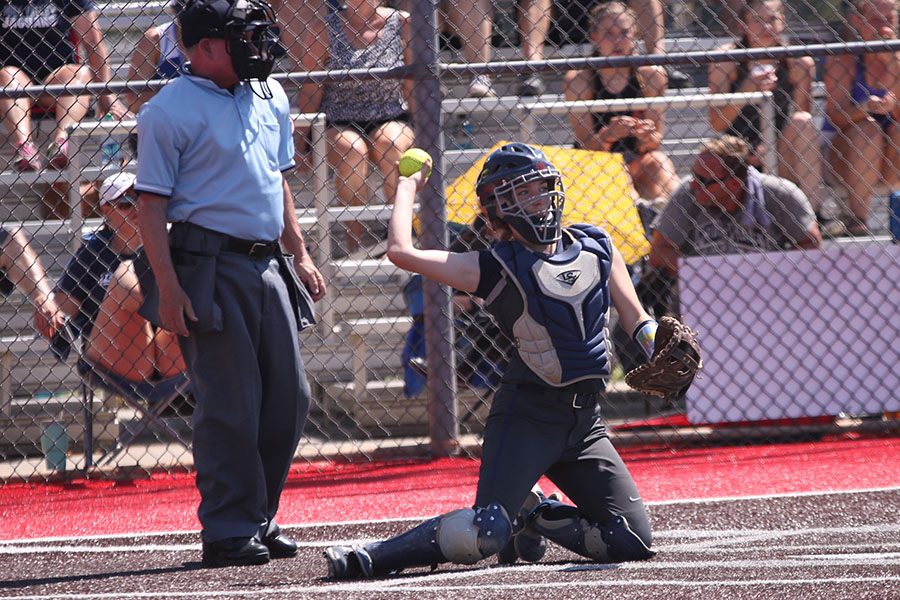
[0,438,900,539]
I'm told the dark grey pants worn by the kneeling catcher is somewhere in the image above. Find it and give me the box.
[475,385,651,547]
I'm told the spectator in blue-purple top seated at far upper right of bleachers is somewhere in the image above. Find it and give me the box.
[823,0,900,236]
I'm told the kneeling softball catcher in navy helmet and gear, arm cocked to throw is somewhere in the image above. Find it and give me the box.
[325,143,704,579]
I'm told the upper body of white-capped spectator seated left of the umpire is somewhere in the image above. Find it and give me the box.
[36,173,141,359]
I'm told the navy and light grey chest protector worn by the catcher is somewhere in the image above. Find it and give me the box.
[487,225,612,387]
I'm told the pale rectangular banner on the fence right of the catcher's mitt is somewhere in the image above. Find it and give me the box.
[679,243,900,423]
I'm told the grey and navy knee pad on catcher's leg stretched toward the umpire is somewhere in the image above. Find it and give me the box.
[437,502,512,565]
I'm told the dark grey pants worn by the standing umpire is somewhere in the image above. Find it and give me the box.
[181,252,309,542]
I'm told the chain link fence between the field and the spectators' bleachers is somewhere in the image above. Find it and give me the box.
[0,0,900,482]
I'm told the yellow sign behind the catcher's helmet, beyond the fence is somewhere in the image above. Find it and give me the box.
[447,142,650,264]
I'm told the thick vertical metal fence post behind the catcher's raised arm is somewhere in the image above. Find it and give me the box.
[410,0,459,456]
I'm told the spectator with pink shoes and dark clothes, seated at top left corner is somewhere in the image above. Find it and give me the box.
[0,0,129,171]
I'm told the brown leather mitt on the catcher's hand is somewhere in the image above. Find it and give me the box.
[625,317,703,402]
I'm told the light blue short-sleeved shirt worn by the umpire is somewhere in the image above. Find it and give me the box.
[135,71,295,241]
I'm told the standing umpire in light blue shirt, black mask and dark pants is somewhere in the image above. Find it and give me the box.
[135,0,325,567]
